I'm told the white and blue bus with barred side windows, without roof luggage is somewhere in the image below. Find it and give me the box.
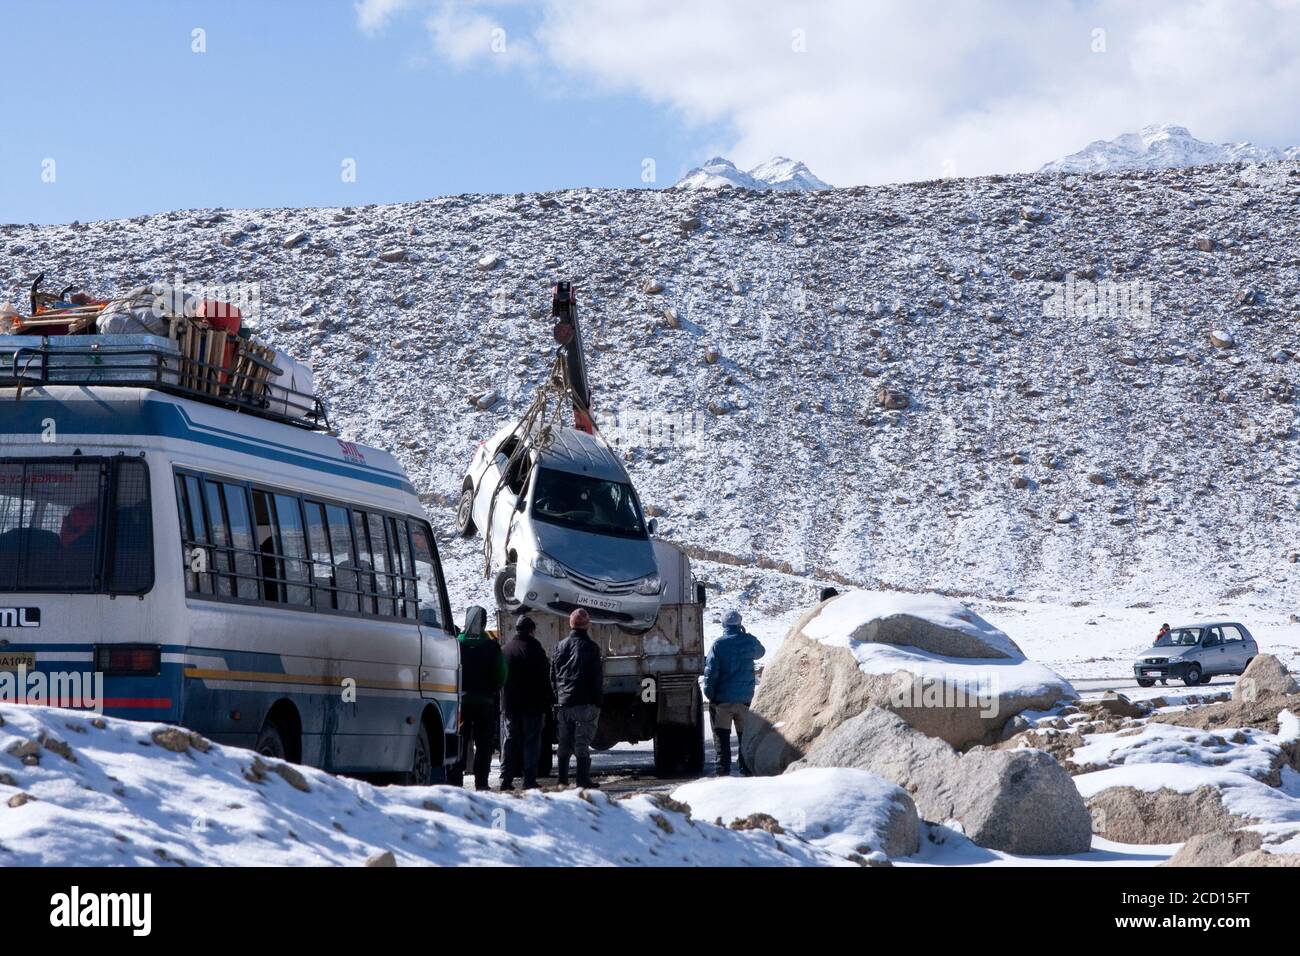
[0,339,460,784]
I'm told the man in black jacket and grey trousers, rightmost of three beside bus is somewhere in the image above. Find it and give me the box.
[551,607,605,788]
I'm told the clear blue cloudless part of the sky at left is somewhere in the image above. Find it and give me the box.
[0,0,710,222]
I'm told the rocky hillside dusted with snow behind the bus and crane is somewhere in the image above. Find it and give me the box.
[0,163,1300,650]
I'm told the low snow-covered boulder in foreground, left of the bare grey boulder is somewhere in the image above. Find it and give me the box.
[672,767,920,858]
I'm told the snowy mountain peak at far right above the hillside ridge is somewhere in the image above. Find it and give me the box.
[1040,124,1300,173]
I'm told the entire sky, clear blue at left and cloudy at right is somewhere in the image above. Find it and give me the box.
[0,0,1300,222]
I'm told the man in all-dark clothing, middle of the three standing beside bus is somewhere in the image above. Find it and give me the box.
[501,615,553,790]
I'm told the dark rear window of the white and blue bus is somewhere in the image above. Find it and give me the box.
[0,457,153,594]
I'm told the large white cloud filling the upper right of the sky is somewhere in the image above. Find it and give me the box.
[353,0,1300,185]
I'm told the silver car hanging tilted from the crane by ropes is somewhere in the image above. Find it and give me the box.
[456,425,663,631]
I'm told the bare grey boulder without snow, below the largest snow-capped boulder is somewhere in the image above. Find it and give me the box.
[787,708,1092,855]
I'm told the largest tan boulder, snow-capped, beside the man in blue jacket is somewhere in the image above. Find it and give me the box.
[742,591,1076,774]
